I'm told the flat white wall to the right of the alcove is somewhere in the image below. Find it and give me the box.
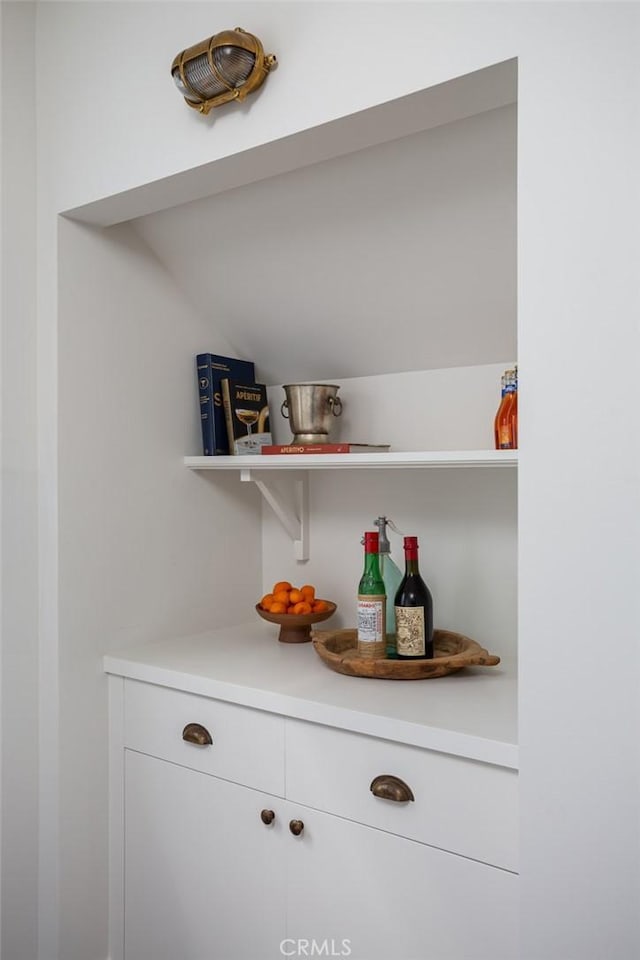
[518,11,640,960]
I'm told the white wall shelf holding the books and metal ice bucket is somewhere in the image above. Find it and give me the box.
[184,450,518,472]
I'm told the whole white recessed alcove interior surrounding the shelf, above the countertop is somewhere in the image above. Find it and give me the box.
[58,61,517,960]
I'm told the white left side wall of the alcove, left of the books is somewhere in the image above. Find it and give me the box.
[58,220,260,958]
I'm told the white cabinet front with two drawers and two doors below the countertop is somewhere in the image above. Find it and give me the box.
[111,678,518,960]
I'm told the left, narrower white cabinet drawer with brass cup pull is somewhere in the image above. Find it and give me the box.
[124,680,284,796]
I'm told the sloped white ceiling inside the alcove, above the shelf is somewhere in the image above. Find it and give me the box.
[132,104,516,383]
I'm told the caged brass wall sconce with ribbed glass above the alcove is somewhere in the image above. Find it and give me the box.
[171,27,276,114]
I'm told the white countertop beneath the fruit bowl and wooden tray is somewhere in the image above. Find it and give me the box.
[104,621,518,769]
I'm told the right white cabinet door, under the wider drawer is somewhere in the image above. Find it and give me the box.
[284,807,518,960]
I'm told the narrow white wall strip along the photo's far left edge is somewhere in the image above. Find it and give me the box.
[0,3,38,960]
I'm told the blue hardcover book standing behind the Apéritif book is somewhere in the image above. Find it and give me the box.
[196,353,255,457]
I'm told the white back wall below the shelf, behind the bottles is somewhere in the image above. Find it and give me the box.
[263,469,517,660]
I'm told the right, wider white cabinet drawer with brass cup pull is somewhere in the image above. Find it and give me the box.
[286,720,518,871]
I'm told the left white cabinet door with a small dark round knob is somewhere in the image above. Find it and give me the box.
[124,750,284,960]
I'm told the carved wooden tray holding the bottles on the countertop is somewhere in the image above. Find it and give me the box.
[311,630,500,680]
